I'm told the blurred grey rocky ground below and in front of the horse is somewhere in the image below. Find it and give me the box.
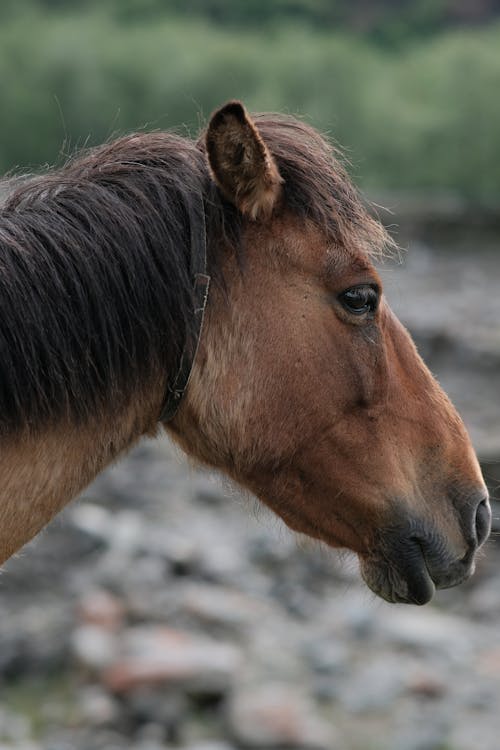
[0,236,500,750]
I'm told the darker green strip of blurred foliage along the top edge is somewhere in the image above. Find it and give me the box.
[0,0,500,46]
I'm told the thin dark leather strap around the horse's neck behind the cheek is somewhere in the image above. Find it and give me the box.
[159,195,210,422]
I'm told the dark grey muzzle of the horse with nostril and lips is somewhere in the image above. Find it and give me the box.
[360,492,491,604]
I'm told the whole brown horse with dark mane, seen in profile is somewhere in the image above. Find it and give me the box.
[0,102,490,603]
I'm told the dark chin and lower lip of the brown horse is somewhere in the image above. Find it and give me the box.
[360,555,436,605]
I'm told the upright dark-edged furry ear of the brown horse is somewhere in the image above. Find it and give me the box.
[206,101,283,220]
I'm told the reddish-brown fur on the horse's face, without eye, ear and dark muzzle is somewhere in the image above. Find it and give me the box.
[171,217,482,555]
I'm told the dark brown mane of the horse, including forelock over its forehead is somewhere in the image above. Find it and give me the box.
[0,115,387,434]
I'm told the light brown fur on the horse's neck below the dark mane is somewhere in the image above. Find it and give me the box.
[0,379,163,563]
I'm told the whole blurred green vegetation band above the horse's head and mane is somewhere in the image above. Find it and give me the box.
[0,0,500,199]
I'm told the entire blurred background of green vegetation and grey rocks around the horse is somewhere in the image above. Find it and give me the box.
[0,0,500,750]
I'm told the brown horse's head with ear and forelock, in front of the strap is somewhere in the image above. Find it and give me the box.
[171,102,490,604]
